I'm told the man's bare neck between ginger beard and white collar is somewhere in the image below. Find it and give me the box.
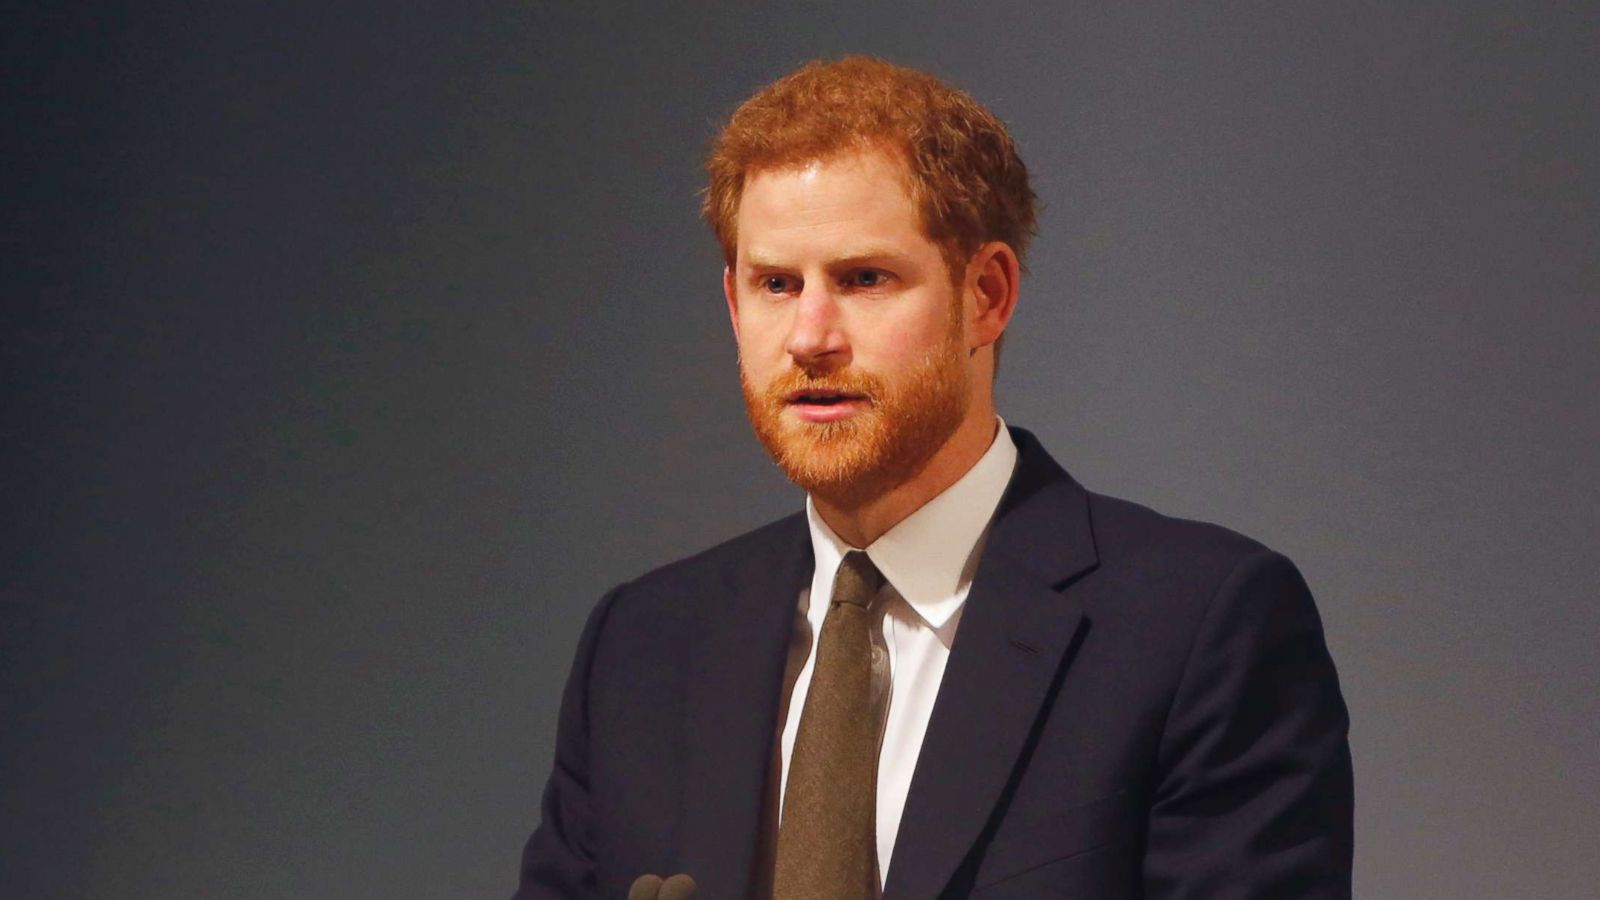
[811,404,1000,548]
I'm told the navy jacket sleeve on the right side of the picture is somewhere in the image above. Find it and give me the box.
[1144,549,1355,900]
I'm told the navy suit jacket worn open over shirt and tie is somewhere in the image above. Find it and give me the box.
[517,429,1354,900]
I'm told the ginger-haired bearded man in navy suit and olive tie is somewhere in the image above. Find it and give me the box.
[518,58,1352,900]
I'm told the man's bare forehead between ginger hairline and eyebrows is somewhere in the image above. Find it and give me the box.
[738,151,928,258]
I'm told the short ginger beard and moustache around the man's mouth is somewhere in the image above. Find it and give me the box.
[739,299,971,506]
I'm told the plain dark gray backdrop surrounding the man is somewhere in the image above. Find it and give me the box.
[0,2,1600,900]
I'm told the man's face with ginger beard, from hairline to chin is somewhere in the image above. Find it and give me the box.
[725,152,973,504]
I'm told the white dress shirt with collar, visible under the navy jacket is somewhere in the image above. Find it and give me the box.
[778,421,1016,884]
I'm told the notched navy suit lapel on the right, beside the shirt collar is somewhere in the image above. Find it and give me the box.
[885,429,1096,900]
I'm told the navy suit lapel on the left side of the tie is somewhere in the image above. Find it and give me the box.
[678,516,811,897]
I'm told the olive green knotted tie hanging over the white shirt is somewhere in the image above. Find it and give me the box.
[773,551,883,900]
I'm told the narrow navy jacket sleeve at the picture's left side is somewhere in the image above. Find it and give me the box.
[512,588,621,900]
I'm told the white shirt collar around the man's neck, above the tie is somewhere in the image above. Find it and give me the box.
[805,416,1016,628]
